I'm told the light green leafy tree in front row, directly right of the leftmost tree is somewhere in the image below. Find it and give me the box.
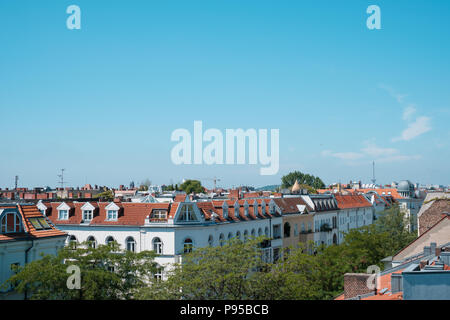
[139,238,265,300]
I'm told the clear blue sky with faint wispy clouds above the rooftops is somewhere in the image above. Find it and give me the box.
[0,0,450,187]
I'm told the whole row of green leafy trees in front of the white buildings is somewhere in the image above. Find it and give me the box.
[3,207,415,300]
